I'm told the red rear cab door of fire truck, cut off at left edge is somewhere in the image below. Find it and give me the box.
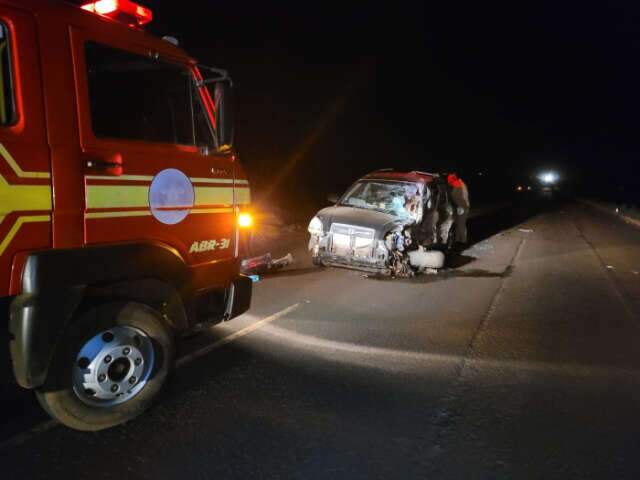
[0,6,51,297]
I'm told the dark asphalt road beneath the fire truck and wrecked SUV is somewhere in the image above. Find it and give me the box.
[0,199,640,480]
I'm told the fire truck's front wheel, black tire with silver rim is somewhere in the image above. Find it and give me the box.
[36,302,174,431]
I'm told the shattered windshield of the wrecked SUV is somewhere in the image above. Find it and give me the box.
[340,181,422,220]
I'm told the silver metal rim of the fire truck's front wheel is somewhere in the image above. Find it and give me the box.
[72,326,155,407]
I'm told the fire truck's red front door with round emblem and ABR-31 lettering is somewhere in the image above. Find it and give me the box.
[72,28,236,282]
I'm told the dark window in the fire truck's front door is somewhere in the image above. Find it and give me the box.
[85,42,214,148]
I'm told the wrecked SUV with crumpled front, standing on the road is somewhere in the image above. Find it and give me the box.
[309,170,454,276]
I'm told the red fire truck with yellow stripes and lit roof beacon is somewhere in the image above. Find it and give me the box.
[0,0,251,430]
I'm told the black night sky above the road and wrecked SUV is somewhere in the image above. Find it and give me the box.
[74,0,640,208]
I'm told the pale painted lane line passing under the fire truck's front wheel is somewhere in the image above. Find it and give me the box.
[0,302,308,451]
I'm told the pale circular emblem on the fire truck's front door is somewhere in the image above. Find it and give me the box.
[149,168,196,225]
